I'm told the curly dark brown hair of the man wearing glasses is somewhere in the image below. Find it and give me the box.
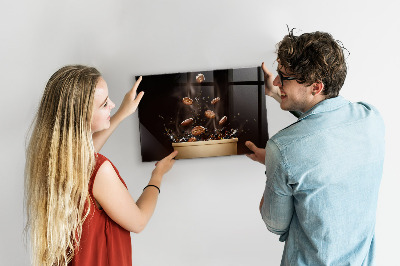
[277,29,347,98]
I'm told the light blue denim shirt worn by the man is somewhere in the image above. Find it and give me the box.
[261,96,385,266]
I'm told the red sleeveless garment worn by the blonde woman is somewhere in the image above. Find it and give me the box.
[69,153,132,266]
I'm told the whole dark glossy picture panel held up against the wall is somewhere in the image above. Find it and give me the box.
[136,67,269,162]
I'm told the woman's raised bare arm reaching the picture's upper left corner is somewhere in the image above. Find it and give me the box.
[92,77,144,152]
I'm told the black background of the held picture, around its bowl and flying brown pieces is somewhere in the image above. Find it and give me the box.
[135,67,269,162]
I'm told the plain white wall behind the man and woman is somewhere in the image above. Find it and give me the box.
[0,0,400,266]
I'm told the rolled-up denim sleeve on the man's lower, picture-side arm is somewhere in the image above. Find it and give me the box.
[261,140,294,241]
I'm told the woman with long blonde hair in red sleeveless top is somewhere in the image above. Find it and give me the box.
[25,65,177,265]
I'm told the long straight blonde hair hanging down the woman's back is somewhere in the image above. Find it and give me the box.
[25,65,101,265]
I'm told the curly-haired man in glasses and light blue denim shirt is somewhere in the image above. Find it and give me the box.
[246,31,384,265]
